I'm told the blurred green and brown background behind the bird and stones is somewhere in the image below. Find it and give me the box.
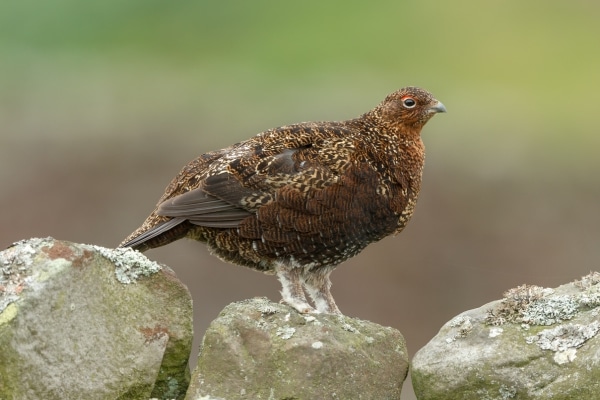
[0,0,600,399]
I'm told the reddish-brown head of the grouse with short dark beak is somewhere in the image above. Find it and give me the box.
[371,86,446,133]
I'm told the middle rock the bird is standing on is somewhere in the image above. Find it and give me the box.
[186,298,408,400]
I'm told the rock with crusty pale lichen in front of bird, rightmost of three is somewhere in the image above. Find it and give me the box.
[411,272,600,400]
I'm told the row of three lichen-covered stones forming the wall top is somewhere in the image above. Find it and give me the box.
[0,238,600,400]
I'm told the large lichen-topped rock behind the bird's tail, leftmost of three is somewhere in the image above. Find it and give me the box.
[0,238,192,400]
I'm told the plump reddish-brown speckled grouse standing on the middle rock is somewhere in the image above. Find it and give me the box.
[119,86,446,314]
